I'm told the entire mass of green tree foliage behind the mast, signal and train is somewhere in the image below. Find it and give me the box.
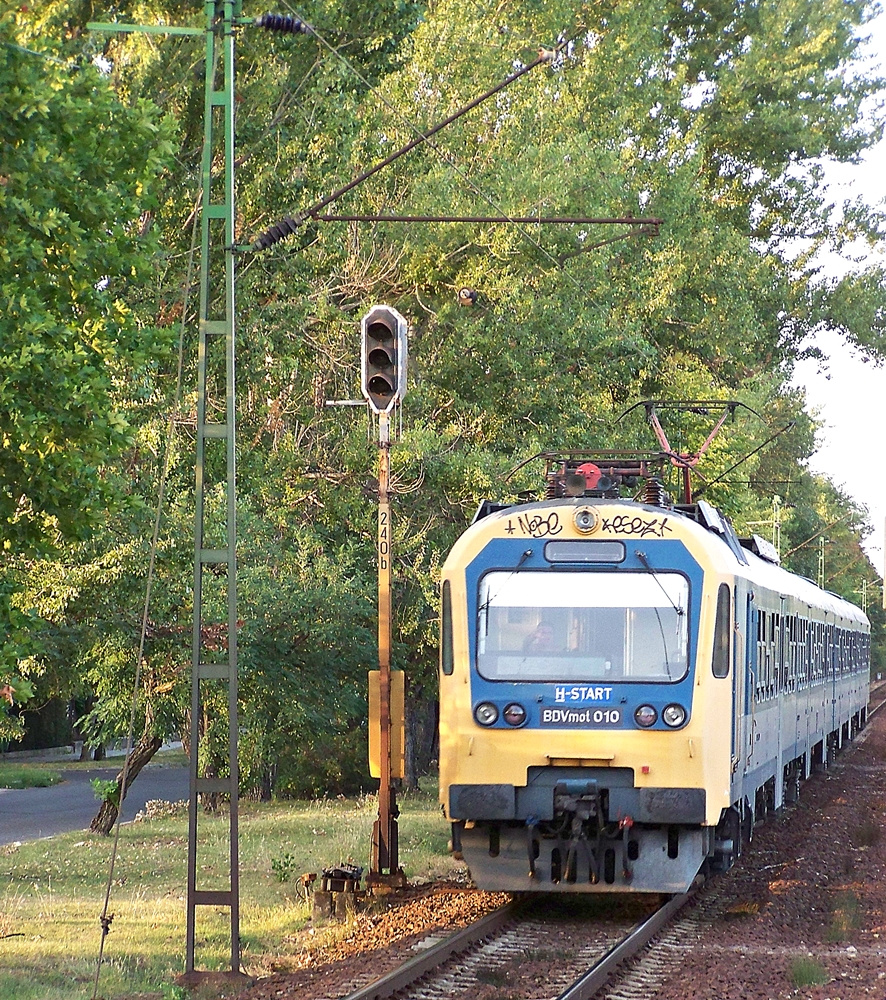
[0,0,884,780]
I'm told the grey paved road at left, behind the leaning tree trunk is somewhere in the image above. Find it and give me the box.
[0,764,188,846]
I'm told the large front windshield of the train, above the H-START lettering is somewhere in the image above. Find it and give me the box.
[477,570,689,681]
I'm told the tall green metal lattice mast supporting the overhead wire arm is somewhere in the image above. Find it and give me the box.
[87,0,242,977]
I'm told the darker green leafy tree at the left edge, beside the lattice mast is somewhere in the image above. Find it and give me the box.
[0,11,171,732]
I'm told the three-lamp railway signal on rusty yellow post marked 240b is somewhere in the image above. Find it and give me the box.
[360,305,407,885]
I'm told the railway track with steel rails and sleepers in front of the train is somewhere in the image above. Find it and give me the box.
[347,894,690,1000]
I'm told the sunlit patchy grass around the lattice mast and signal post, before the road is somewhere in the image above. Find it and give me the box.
[0,776,455,1000]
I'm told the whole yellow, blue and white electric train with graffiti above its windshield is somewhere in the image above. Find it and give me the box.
[440,455,870,893]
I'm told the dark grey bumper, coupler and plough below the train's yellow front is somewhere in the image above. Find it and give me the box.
[451,767,717,893]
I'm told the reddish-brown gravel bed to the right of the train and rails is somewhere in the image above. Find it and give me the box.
[636,709,886,1000]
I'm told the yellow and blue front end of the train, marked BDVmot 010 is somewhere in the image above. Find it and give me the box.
[440,502,742,893]
